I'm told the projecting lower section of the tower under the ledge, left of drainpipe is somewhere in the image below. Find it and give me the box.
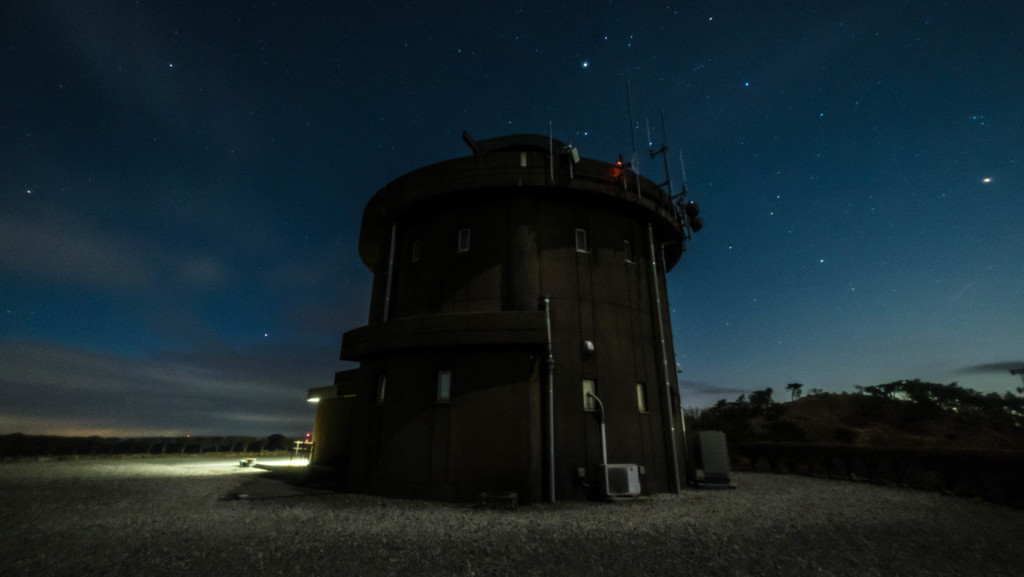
[313,346,541,499]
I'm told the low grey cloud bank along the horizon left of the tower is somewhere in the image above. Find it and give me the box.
[0,340,327,435]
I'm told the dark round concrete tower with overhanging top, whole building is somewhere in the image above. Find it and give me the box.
[308,134,699,502]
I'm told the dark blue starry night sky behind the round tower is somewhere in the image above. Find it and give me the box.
[0,0,1024,436]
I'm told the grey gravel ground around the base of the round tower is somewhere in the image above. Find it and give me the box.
[0,458,1024,577]
